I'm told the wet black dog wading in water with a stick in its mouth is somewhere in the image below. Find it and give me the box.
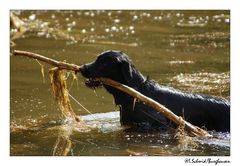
[80,51,230,131]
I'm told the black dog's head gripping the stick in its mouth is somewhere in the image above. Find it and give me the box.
[80,51,138,88]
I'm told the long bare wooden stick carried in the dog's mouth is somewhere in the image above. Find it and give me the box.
[14,50,211,137]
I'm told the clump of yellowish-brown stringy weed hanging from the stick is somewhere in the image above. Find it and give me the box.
[49,67,81,122]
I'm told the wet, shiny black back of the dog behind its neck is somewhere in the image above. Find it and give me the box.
[136,81,230,131]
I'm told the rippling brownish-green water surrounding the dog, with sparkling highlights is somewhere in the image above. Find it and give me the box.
[10,11,230,156]
